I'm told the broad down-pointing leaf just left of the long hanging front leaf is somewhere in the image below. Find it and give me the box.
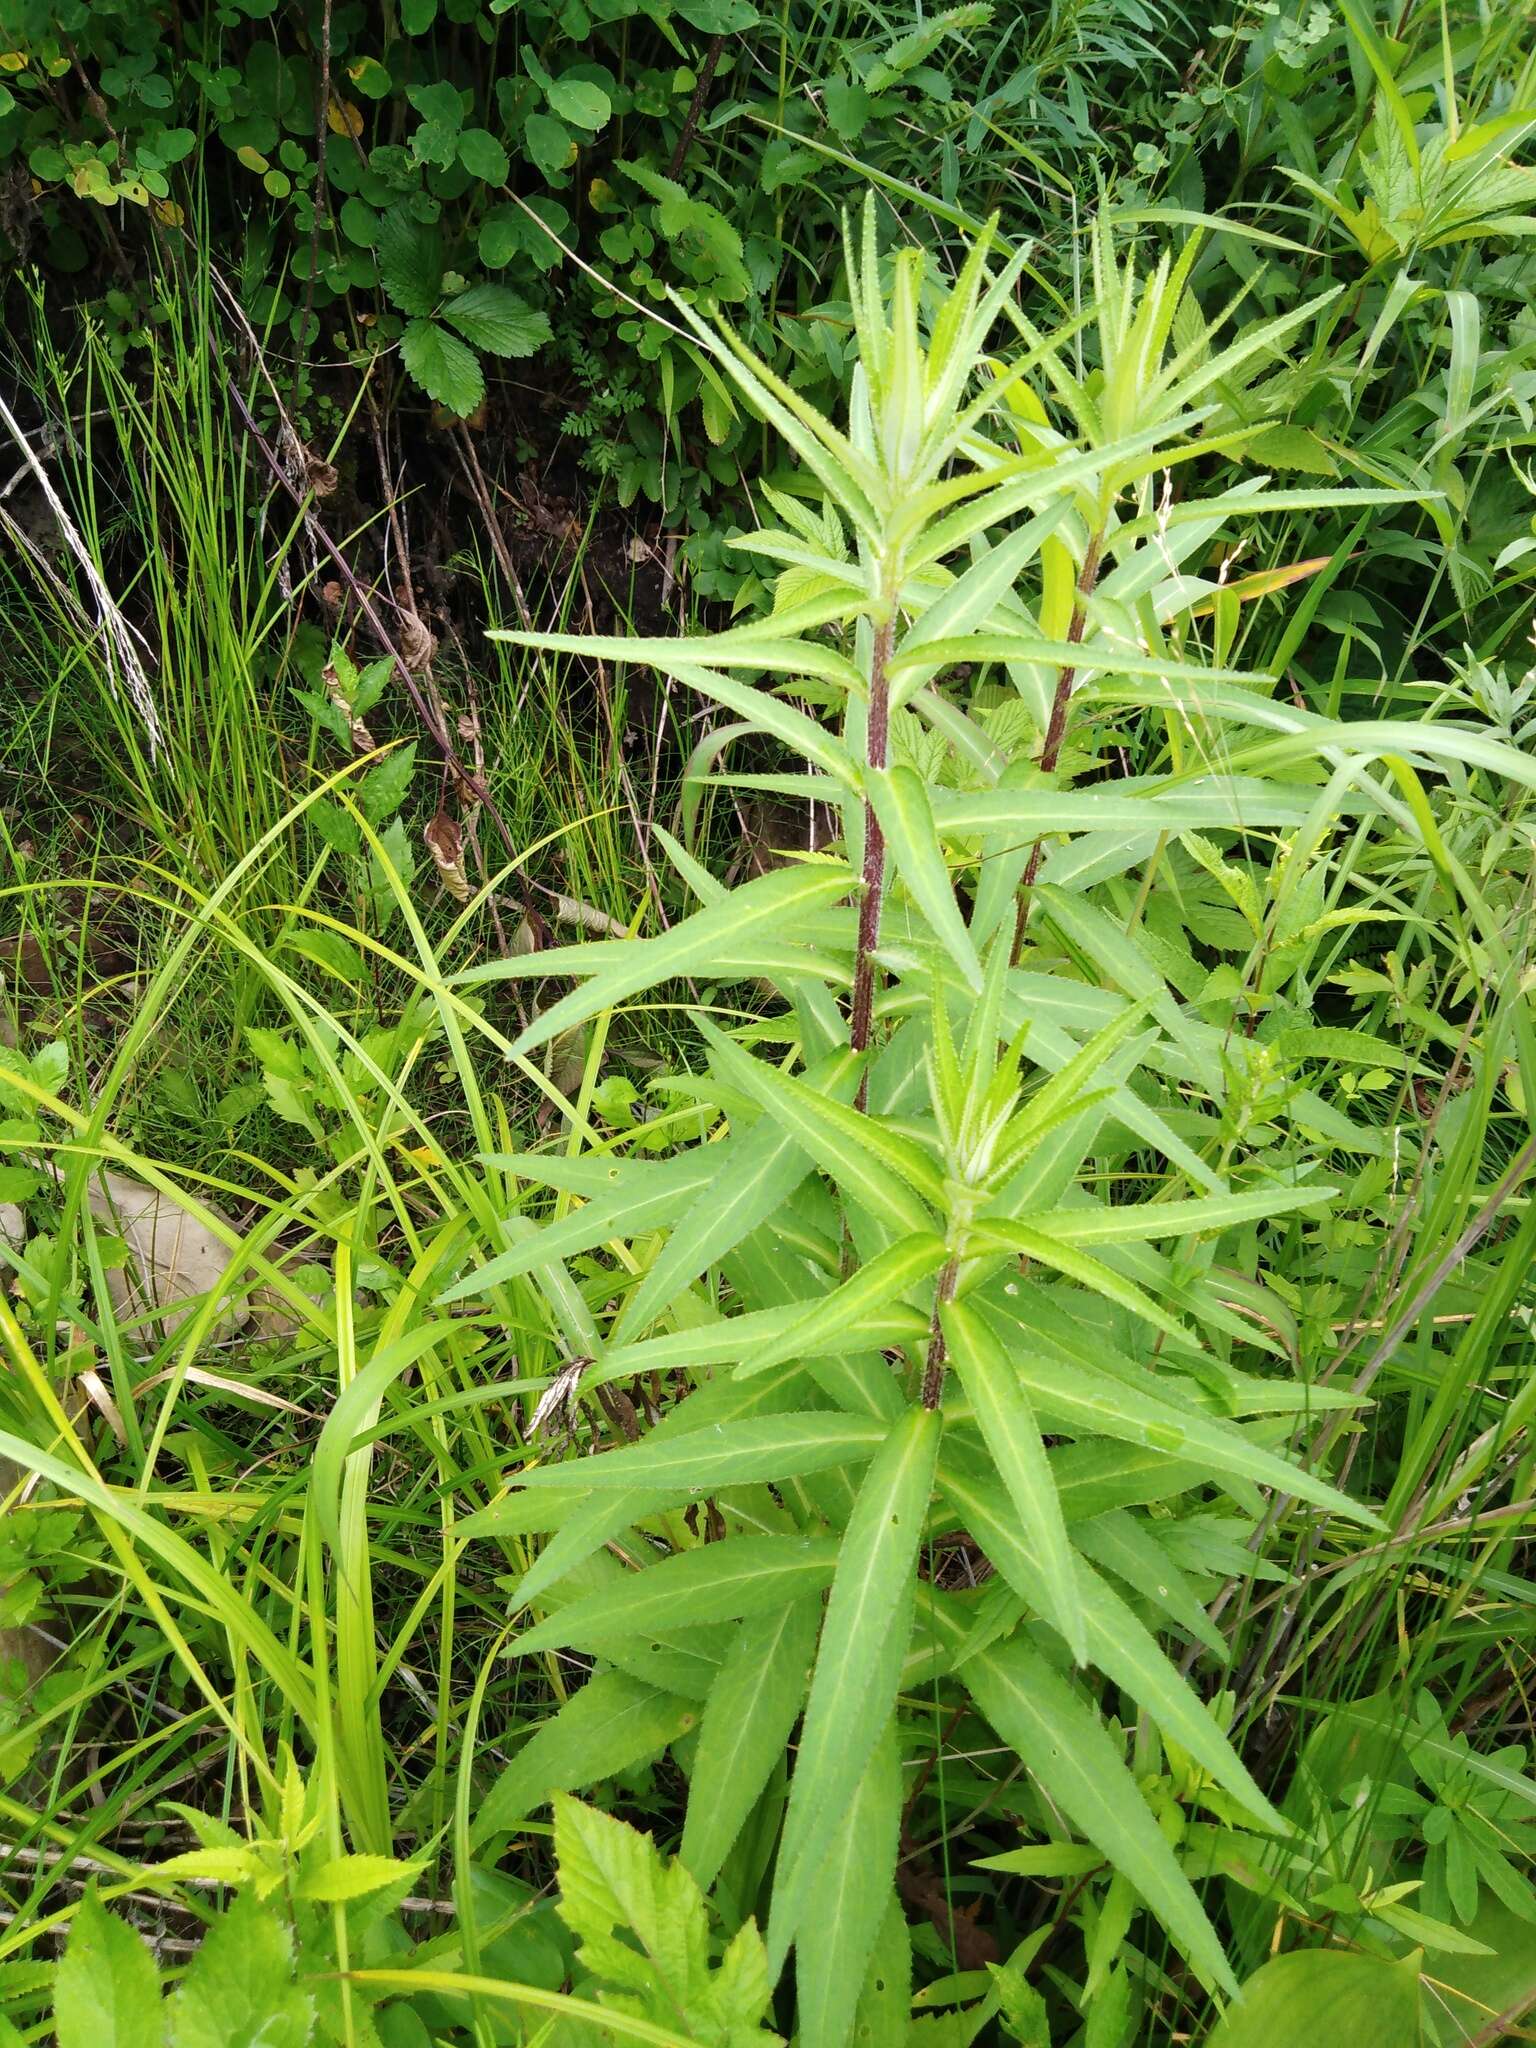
[678,1597,821,1890]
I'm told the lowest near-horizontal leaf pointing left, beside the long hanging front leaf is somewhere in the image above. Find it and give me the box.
[516,1536,838,1655]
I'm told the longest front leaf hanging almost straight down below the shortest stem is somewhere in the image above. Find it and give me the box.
[768,1407,940,1972]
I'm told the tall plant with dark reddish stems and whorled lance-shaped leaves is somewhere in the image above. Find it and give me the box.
[378,195,1530,2044]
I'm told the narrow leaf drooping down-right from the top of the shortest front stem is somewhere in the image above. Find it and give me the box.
[942,1303,1087,1663]
